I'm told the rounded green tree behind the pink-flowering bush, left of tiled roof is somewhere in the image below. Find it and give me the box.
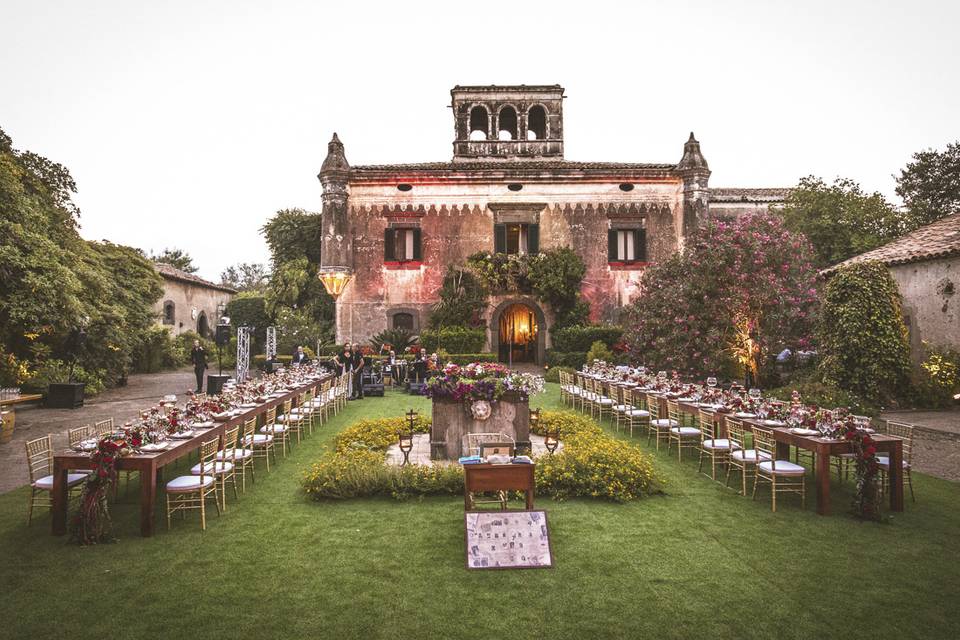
[781,176,912,267]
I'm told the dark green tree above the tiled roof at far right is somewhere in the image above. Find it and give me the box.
[896,141,960,227]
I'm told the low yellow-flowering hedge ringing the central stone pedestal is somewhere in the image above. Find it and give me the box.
[303,411,659,502]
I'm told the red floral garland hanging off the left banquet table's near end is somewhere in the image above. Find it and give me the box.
[70,434,133,545]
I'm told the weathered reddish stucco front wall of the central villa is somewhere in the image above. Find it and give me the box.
[337,178,683,349]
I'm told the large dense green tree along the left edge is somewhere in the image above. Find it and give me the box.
[0,125,162,383]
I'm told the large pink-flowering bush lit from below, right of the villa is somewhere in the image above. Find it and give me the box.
[624,213,817,376]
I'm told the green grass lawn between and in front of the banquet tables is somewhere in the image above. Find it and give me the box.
[0,385,960,639]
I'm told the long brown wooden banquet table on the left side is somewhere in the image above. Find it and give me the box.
[52,374,333,537]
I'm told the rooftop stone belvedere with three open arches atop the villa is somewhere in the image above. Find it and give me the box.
[450,84,564,162]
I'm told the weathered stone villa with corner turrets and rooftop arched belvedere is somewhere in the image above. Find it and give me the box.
[319,85,785,363]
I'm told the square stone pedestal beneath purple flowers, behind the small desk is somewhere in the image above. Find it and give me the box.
[430,392,530,460]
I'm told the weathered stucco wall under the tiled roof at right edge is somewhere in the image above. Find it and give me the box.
[890,257,960,360]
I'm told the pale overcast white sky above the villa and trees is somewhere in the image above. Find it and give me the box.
[0,0,960,280]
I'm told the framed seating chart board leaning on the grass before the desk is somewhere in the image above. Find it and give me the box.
[464,511,553,569]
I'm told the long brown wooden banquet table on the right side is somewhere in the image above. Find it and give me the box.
[596,378,903,515]
